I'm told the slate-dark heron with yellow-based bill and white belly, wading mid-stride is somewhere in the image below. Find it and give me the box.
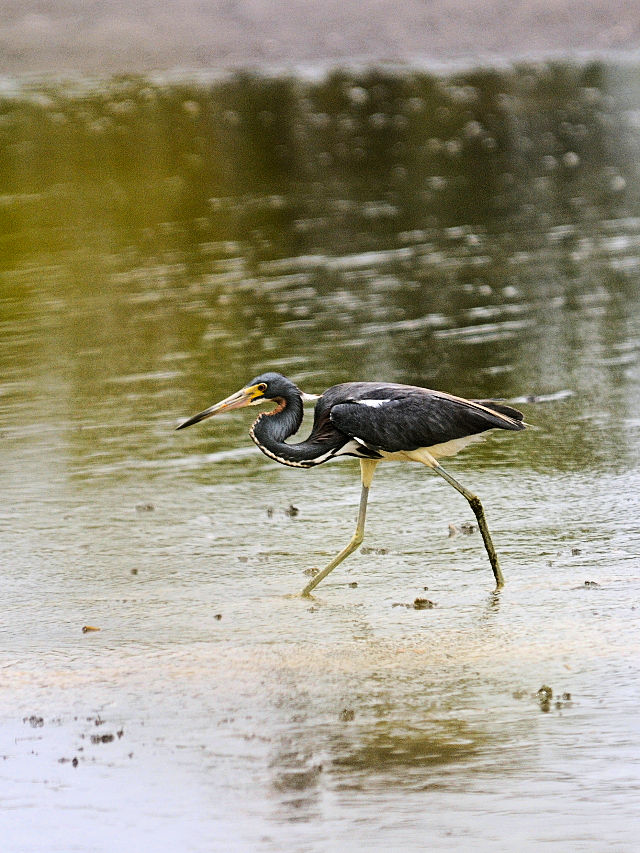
[178,373,525,595]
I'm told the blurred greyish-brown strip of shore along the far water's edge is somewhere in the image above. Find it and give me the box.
[0,0,640,74]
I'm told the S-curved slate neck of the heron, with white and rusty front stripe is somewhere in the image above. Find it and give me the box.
[249,394,331,468]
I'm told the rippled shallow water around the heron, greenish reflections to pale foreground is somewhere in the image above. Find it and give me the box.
[0,65,640,853]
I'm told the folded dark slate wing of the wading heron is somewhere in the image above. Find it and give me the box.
[323,383,524,452]
